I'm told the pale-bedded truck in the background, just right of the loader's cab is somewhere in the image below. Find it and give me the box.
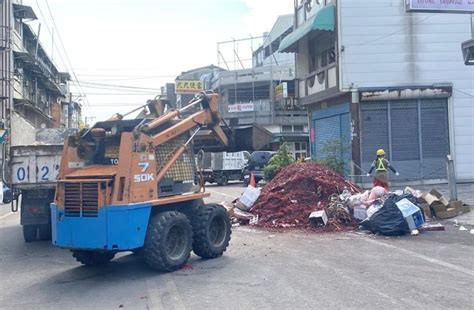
[198,151,250,186]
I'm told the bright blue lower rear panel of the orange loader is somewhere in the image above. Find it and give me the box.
[51,203,151,251]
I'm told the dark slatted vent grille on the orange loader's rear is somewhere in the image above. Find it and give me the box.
[64,182,99,217]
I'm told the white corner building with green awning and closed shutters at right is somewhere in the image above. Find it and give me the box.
[280,0,474,181]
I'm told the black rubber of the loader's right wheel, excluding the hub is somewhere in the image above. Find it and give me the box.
[193,204,232,259]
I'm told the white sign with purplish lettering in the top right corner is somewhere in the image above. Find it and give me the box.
[406,0,474,14]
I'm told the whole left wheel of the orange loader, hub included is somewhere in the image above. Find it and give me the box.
[143,211,193,271]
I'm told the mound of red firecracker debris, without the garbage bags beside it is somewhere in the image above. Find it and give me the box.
[250,163,360,231]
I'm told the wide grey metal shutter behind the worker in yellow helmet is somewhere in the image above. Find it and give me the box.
[361,99,449,180]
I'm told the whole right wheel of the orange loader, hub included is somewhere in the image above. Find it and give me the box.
[193,204,232,259]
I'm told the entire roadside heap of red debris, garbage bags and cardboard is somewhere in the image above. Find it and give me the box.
[223,163,470,236]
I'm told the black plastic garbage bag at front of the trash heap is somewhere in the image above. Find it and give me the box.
[361,194,416,236]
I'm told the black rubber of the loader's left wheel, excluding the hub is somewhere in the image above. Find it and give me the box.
[143,211,193,271]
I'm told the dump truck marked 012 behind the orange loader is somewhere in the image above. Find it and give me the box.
[9,128,77,242]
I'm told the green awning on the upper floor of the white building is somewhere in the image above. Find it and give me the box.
[278,4,336,53]
